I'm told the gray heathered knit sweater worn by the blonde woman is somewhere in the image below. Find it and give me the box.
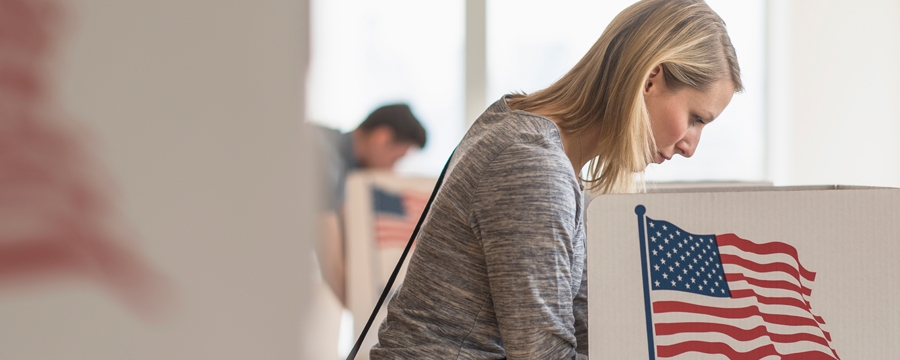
[370,98,588,360]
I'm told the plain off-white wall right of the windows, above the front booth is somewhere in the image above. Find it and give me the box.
[769,0,900,186]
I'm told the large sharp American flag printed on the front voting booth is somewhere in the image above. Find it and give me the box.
[639,207,839,359]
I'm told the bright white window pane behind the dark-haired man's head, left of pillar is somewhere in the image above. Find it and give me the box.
[306,0,465,177]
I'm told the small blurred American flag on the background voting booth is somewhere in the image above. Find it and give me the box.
[372,186,431,248]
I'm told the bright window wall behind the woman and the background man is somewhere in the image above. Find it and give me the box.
[306,0,900,186]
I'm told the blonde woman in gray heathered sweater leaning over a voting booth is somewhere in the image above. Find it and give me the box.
[370,0,742,359]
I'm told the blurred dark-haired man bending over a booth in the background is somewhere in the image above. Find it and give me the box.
[315,104,426,303]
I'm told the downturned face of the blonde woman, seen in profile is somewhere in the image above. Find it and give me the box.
[644,66,734,164]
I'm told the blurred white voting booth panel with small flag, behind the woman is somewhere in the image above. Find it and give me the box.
[344,172,437,359]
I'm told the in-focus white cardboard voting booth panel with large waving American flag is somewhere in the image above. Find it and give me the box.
[587,186,900,359]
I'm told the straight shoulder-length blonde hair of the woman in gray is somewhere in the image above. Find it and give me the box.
[508,0,743,193]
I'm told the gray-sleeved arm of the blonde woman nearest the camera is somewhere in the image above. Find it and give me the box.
[472,144,584,359]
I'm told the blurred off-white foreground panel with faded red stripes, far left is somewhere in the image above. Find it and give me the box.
[0,0,320,360]
